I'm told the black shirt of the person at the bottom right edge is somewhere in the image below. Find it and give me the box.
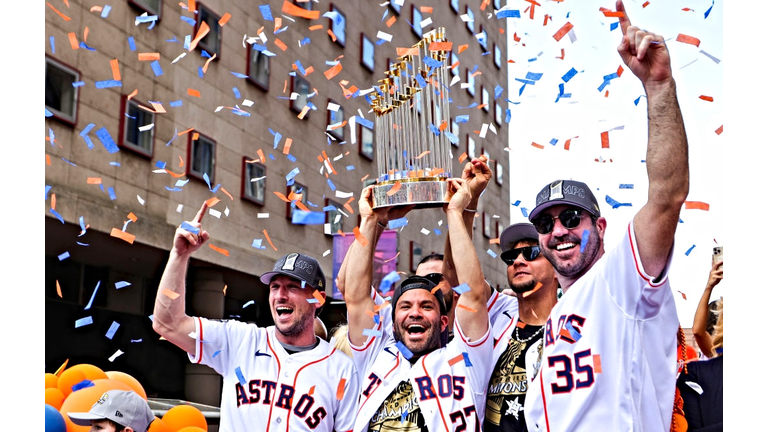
[677,355,723,432]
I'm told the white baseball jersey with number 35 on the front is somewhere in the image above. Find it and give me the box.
[525,222,679,432]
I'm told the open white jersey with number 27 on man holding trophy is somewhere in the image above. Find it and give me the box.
[351,294,493,432]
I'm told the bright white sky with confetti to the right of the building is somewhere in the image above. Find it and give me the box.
[506,0,728,327]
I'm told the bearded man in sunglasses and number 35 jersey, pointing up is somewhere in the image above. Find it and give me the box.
[525,0,689,431]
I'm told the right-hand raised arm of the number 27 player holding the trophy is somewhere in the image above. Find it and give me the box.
[445,179,488,341]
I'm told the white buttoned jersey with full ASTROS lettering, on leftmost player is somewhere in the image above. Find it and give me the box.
[189,318,360,432]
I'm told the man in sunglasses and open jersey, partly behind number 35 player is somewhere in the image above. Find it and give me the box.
[483,223,557,432]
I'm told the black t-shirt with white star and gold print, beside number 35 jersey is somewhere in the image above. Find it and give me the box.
[483,325,544,432]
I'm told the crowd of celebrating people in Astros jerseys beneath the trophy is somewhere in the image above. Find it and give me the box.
[137,0,722,432]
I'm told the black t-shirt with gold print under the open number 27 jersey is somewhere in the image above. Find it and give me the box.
[368,380,429,432]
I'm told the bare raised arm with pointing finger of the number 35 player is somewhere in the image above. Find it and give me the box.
[616,0,689,276]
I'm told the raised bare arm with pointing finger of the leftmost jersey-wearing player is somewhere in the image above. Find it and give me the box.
[152,202,210,355]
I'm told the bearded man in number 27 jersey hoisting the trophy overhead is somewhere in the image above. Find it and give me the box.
[337,179,493,432]
